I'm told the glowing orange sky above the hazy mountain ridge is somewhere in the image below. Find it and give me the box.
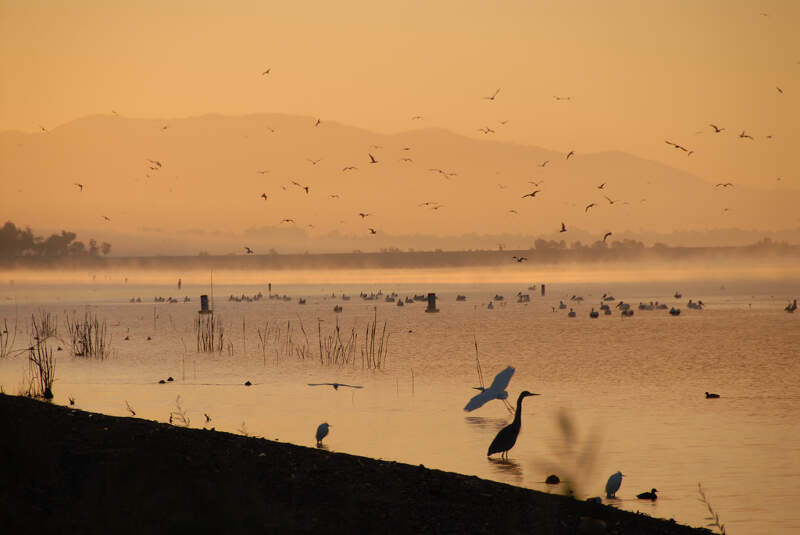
[0,0,800,252]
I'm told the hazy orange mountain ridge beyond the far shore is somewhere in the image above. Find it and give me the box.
[0,114,800,254]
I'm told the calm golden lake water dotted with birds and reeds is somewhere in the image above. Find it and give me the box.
[0,268,800,534]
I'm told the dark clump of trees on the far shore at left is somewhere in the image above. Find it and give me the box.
[0,221,111,257]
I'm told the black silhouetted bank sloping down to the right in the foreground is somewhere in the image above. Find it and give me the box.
[0,395,708,535]
